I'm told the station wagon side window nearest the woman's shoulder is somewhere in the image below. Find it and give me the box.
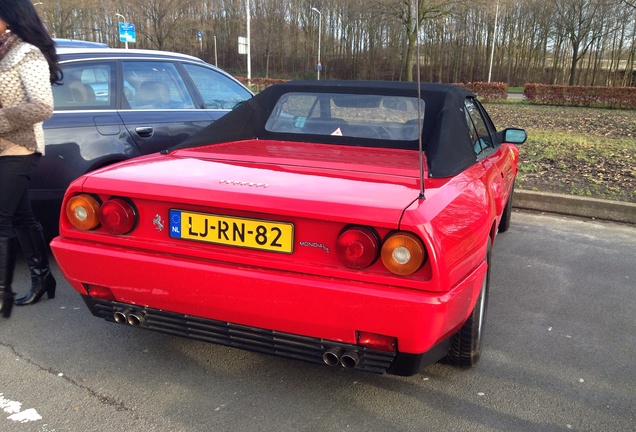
[52,62,115,110]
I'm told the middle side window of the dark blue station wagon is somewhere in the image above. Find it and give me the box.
[122,61,195,110]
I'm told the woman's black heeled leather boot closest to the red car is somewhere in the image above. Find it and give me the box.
[15,224,56,306]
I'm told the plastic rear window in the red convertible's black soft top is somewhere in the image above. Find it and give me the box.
[265,92,424,141]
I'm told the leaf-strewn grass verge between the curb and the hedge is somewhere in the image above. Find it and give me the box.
[486,102,636,202]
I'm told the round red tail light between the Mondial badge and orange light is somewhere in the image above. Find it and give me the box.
[336,227,380,270]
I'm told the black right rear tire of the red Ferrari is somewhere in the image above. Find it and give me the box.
[446,240,490,368]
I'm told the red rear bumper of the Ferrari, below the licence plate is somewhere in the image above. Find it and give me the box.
[51,237,486,375]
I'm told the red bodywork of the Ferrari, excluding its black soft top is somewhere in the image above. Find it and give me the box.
[51,83,525,375]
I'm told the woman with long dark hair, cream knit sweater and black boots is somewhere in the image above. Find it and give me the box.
[0,0,62,318]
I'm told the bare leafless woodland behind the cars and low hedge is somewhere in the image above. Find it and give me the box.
[33,0,636,86]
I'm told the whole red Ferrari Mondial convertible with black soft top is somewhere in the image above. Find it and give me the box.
[51,81,526,375]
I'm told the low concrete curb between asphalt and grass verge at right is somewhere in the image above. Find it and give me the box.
[512,190,636,224]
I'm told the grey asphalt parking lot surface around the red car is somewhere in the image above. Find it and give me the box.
[0,212,636,432]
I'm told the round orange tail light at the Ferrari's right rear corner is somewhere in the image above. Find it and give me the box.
[381,232,426,276]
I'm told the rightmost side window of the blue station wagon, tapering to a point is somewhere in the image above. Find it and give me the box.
[183,63,252,110]
